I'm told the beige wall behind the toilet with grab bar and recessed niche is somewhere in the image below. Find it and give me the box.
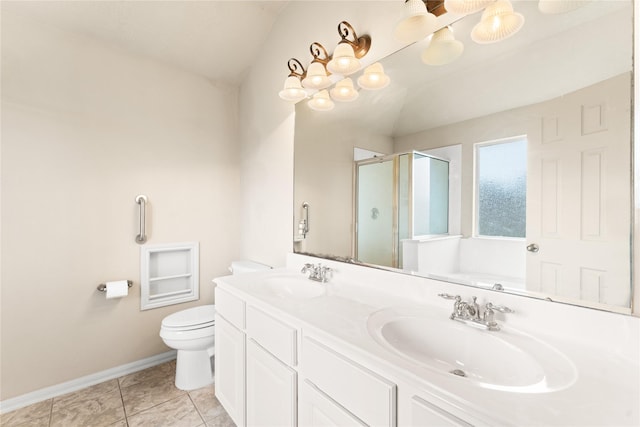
[0,13,240,400]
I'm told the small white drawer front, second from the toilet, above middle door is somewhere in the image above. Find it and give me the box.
[247,306,298,366]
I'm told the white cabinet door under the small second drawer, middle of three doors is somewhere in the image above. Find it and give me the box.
[247,339,297,427]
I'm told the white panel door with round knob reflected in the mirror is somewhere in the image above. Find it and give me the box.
[527,75,631,306]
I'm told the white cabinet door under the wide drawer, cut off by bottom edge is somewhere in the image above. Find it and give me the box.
[298,380,366,427]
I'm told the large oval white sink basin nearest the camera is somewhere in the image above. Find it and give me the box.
[367,308,577,393]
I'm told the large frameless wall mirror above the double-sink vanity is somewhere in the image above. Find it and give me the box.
[293,0,633,313]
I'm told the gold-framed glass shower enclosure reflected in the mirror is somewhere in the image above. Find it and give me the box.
[354,151,449,268]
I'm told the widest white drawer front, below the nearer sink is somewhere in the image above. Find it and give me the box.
[301,337,396,426]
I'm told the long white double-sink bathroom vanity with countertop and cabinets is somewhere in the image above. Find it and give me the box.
[215,254,640,426]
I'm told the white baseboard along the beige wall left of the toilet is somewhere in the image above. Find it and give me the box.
[0,350,176,414]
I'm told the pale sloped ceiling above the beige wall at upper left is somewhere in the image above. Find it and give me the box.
[0,0,289,85]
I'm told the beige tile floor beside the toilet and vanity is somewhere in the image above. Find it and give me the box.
[0,361,235,427]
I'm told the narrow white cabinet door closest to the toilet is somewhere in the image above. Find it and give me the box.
[215,315,245,426]
